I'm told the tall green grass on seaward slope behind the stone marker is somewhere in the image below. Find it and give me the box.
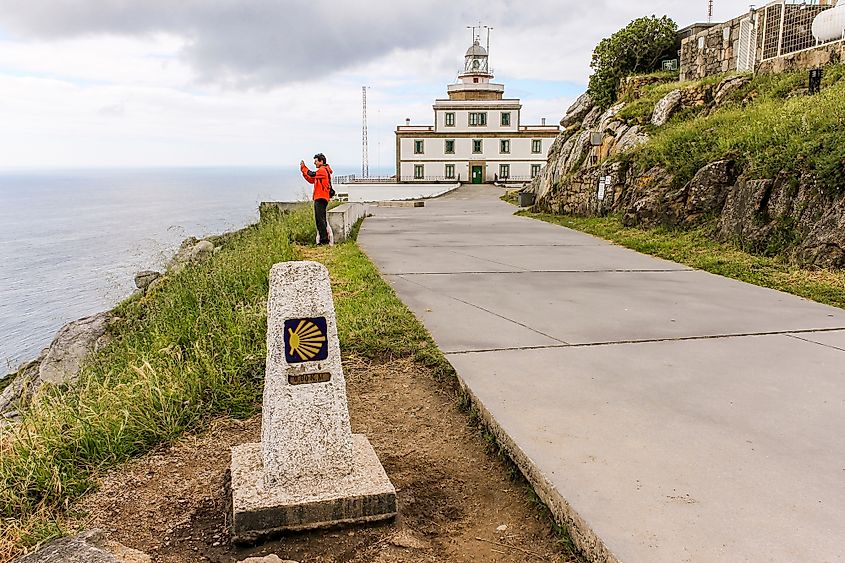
[0,202,453,561]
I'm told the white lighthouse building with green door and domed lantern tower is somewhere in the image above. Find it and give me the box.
[396,35,560,184]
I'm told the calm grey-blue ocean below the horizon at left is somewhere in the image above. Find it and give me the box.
[0,168,446,377]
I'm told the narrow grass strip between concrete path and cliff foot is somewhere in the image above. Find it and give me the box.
[518,211,845,309]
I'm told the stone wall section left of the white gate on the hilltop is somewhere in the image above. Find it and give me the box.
[680,14,748,80]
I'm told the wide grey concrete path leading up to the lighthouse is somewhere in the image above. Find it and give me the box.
[358,187,845,562]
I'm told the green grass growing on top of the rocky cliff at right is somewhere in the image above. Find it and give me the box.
[619,65,845,193]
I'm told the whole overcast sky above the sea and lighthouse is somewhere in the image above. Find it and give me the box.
[0,0,748,168]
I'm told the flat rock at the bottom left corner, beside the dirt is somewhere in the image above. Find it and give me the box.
[15,530,152,563]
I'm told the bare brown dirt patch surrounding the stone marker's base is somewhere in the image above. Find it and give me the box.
[74,358,569,563]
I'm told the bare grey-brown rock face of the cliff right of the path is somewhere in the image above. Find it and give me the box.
[526,75,845,268]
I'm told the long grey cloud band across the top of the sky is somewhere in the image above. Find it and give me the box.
[0,0,752,89]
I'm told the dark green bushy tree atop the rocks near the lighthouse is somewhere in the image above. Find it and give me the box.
[589,16,678,109]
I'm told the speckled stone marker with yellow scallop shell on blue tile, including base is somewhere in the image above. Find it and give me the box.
[227,262,396,541]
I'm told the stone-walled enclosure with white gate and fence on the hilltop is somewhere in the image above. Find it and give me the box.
[680,0,845,80]
